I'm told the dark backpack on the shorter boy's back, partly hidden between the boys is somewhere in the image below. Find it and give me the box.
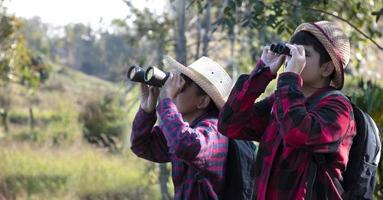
[223,139,257,200]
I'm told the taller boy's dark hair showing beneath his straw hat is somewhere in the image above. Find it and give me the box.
[290,31,335,65]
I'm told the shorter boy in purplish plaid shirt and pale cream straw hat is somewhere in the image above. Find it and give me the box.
[131,57,232,200]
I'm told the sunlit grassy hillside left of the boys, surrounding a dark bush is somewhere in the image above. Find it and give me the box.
[0,67,164,199]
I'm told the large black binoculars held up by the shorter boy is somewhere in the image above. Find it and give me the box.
[126,65,170,87]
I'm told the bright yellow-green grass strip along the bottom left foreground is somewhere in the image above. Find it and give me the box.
[0,144,159,199]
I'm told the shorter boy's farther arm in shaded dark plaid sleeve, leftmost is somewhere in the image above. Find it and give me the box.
[130,108,170,163]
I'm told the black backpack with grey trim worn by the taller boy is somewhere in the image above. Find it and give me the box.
[306,90,381,200]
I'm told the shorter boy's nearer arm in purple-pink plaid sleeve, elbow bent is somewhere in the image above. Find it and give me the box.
[157,98,228,169]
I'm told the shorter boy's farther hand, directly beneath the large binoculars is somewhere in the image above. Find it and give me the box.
[140,83,160,113]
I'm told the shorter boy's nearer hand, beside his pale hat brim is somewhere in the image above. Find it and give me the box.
[162,73,185,99]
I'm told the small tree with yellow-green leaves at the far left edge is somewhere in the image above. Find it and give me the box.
[0,13,48,132]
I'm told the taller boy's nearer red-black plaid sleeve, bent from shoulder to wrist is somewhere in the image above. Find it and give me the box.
[273,72,353,153]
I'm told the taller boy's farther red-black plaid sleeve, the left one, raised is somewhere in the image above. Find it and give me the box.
[218,60,275,141]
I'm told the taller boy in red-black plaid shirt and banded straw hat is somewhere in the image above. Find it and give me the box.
[218,21,356,200]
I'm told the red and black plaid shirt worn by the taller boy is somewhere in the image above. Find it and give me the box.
[218,61,356,200]
